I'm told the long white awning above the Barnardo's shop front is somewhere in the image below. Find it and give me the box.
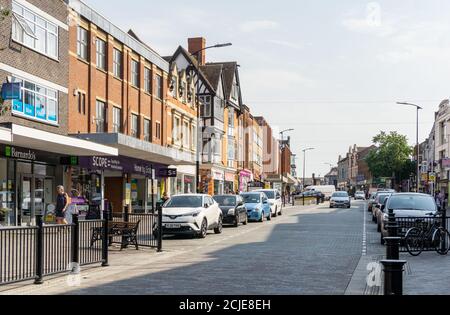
[0,124,118,156]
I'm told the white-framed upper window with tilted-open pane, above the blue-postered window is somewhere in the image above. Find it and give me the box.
[12,1,58,59]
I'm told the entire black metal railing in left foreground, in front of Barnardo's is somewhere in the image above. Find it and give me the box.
[0,215,108,285]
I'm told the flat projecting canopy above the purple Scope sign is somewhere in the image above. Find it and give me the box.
[73,133,195,165]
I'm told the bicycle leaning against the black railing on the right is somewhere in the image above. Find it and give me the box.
[405,215,450,256]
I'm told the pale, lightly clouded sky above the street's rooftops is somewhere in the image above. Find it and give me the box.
[85,0,450,177]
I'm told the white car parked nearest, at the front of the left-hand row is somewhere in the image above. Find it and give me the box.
[162,194,223,238]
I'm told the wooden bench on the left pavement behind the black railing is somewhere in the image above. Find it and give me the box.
[91,220,141,250]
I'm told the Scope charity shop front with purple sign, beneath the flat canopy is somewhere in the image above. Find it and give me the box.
[76,156,167,217]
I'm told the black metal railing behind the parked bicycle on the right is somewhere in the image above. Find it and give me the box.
[395,216,450,253]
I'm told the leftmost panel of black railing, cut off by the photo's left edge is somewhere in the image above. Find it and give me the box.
[0,227,37,284]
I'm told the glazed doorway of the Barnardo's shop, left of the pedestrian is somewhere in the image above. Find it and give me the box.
[19,174,55,226]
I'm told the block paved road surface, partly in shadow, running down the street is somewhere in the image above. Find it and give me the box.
[0,202,365,295]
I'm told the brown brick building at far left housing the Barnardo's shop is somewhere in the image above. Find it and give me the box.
[0,0,117,225]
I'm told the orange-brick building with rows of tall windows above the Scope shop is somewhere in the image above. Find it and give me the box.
[67,0,195,216]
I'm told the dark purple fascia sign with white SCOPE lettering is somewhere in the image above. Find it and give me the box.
[79,156,167,177]
